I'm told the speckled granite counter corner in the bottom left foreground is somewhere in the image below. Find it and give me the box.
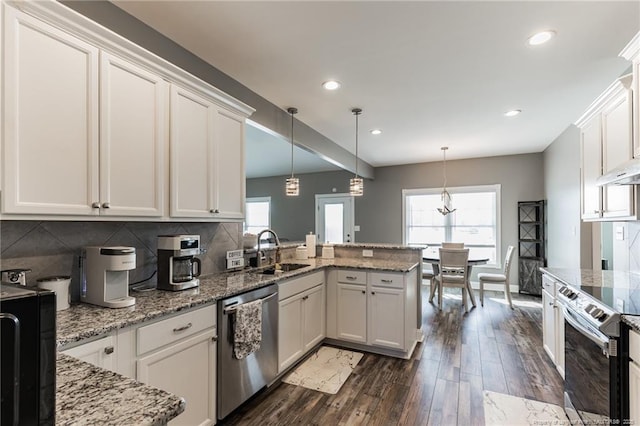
[56,354,185,425]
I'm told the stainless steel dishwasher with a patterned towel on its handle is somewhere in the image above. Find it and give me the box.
[217,284,278,419]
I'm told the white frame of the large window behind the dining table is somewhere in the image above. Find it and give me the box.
[402,183,502,268]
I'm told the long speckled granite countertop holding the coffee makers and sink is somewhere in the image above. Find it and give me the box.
[57,258,418,348]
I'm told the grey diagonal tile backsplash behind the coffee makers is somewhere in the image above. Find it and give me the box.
[0,221,242,301]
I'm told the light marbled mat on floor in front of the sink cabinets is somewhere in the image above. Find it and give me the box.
[282,346,362,394]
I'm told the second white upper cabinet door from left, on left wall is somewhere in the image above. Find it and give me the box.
[100,52,168,217]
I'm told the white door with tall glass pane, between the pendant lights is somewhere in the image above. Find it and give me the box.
[316,194,355,244]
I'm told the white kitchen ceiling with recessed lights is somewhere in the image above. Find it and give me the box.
[115,0,640,174]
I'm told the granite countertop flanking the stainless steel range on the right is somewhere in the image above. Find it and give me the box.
[540,267,640,332]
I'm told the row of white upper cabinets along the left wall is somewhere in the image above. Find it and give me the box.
[0,2,253,220]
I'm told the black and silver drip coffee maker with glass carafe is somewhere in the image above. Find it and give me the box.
[158,235,201,291]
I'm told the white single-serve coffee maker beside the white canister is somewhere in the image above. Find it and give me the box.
[80,247,136,308]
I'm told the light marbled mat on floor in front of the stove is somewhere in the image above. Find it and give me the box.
[483,391,569,426]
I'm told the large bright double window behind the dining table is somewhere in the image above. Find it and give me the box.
[402,185,500,266]
